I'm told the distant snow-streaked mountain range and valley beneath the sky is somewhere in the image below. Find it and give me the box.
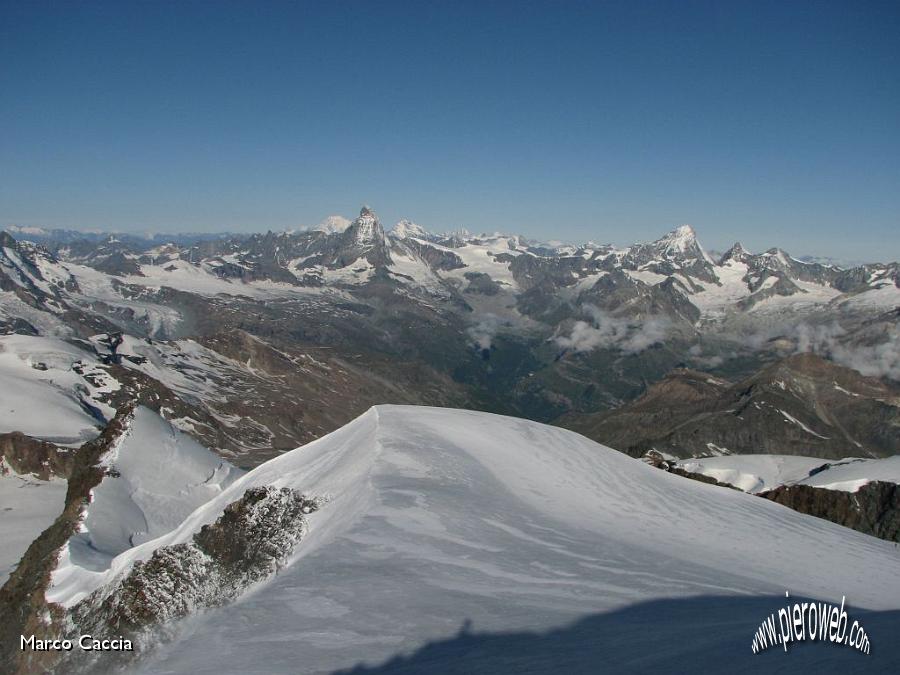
[0,207,900,461]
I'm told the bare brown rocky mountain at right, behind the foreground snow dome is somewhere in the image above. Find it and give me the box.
[559,354,900,459]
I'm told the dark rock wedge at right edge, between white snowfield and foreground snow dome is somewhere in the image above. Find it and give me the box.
[759,481,900,542]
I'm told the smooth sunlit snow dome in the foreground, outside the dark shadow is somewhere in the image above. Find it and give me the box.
[82,406,900,673]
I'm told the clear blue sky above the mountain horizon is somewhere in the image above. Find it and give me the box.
[0,0,900,259]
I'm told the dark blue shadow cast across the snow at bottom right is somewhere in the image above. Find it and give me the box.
[339,596,900,675]
